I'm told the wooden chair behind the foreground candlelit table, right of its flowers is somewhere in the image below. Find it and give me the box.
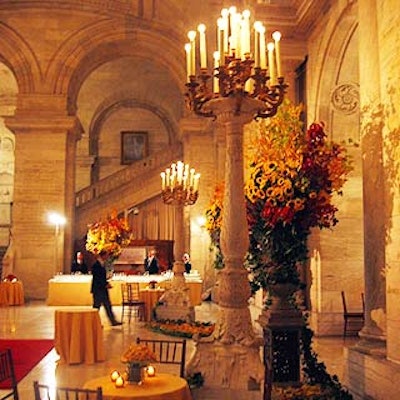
[136,337,186,378]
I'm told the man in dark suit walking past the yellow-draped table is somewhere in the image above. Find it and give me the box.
[91,251,122,326]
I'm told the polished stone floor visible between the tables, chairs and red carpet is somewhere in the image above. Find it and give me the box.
[0,302,356,400]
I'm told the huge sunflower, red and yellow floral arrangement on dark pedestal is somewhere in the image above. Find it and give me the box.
[245,102,351,289]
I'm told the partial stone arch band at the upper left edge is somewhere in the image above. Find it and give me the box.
[0,24,42,94]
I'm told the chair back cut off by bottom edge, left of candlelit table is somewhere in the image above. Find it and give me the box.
[33,381,103,400]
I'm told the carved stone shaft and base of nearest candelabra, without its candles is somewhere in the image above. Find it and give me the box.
[187,94,264,390]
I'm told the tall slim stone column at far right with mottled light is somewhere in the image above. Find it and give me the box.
[358,0,386,340]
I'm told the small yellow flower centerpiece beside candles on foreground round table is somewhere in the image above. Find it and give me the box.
[121,343,157,384]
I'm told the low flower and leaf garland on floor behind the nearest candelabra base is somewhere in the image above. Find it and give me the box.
[149,320,215,338]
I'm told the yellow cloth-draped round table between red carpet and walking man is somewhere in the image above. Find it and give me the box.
[54,309,105,364]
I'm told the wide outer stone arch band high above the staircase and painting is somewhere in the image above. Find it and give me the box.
[46,18,185,113]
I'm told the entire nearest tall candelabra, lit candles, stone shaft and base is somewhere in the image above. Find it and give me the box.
[185,7,286,399]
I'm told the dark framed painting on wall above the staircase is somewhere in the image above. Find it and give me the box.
[121,131,148,164]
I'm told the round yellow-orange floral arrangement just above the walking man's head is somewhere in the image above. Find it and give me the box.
[86,211,133,258]
